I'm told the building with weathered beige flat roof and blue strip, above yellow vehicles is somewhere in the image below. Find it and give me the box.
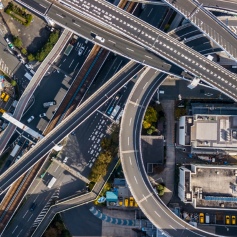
[178,164,237,210]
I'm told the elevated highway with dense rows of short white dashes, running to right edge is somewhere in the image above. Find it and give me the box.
[49,0,237,100]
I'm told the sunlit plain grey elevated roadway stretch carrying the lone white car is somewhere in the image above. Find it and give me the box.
[47,5,170,71]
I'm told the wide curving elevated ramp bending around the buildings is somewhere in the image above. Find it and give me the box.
[120,69,218,237]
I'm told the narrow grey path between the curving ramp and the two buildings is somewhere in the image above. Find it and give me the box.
[153,100,175,205]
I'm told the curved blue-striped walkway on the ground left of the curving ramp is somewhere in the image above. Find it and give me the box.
[90,206,135,226]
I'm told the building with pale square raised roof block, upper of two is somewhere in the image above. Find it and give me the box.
[179,114,237,155]
